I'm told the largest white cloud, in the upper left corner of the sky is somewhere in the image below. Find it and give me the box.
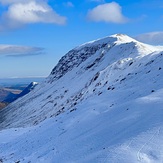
[0,0,66,29]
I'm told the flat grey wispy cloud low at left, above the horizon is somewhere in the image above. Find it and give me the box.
[0,45,45,57]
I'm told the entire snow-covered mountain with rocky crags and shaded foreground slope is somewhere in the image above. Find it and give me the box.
[0,34,163,163]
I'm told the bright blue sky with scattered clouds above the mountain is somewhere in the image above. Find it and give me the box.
[0,0,163,78]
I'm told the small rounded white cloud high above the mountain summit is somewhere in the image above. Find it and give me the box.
[87,2,127,23]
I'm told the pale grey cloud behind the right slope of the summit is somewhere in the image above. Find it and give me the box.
[135,31,163,45]
